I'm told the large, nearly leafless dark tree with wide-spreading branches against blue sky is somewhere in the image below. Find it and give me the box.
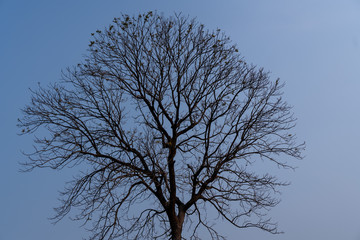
[19,12,303,240]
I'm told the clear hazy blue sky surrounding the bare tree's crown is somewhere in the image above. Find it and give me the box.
[0,0,360,240]
